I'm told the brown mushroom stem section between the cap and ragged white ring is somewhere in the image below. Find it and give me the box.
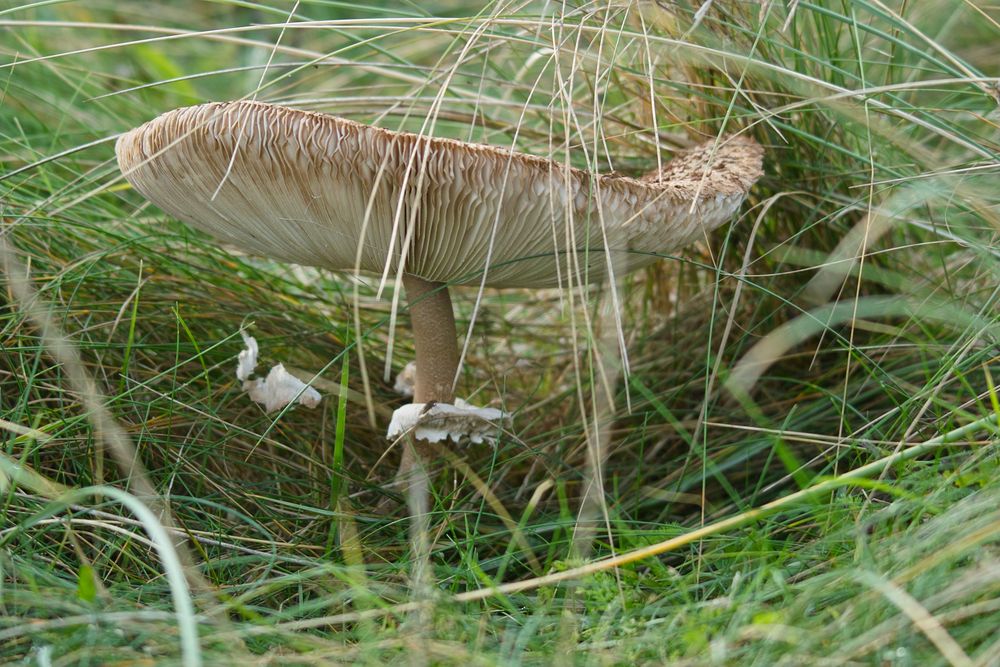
[403,273,458,403]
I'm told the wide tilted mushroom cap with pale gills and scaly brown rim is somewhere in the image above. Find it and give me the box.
[115,101,763,287]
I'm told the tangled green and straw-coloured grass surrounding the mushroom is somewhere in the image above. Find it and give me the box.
[0,0,1000,665]
